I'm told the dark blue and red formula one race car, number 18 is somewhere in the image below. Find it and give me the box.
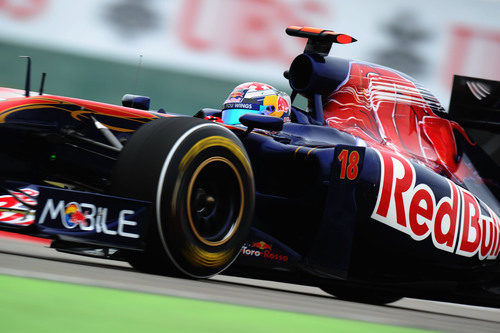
[0,27,500,306]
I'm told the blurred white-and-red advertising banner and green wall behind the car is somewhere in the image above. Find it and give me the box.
[0,0,500,114]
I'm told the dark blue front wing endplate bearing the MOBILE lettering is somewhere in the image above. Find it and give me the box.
[35,186,151,249]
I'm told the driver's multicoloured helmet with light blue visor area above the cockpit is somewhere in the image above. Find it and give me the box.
[222,82,292,125]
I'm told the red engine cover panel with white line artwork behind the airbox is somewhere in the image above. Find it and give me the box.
[324,62,472,181]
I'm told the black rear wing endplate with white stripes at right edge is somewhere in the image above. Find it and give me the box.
[449,75,500,134]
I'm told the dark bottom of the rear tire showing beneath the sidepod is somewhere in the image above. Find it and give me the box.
[321,285,402,305]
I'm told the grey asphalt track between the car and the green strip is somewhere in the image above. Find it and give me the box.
[0,238,500,333]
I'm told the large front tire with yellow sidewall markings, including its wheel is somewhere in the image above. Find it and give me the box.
[112,117,255,278]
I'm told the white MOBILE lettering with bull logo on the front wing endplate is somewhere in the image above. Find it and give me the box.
[38,199,139,238]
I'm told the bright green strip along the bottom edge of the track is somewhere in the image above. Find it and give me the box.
[0,276,430,333]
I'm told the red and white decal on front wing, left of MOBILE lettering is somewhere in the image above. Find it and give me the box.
[0,187,38,225]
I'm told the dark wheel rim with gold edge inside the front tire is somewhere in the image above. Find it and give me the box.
[186,156,245,246]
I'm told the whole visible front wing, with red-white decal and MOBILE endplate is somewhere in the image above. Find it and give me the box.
[0,185,151,250]
